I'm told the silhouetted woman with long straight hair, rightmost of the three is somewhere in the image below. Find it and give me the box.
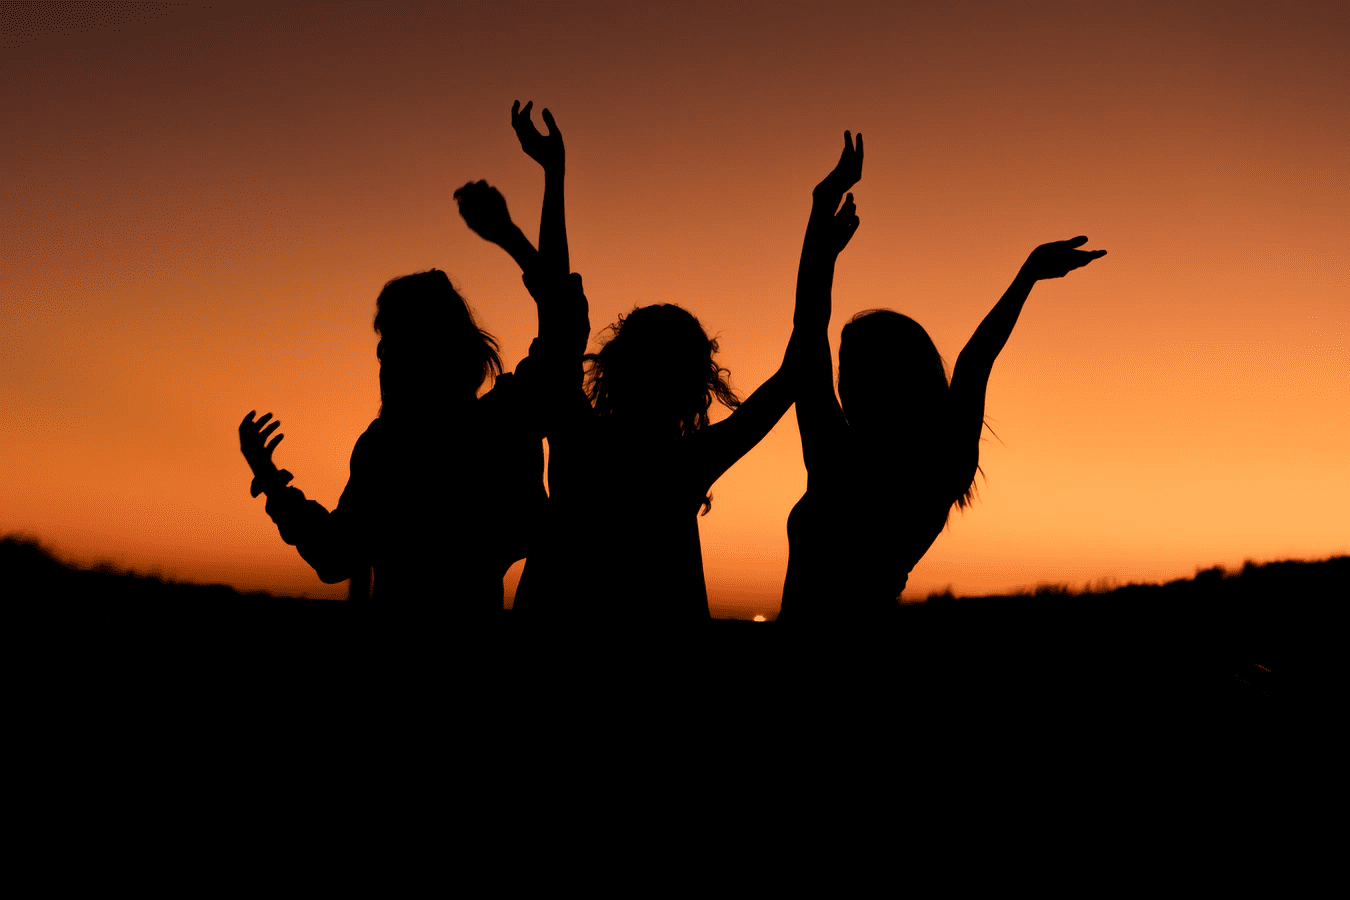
[778,132,1106,623]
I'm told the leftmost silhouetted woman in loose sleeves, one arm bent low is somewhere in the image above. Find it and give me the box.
[239,142,575,618]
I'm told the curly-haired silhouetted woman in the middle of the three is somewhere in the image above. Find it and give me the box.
[469,109,846,625]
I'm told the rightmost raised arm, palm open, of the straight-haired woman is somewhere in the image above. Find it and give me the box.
[952,236,1106,447]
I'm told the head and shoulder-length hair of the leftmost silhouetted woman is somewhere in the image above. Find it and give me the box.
[374,269,502,416]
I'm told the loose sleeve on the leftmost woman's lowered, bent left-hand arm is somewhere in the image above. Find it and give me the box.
[267,420,379,584]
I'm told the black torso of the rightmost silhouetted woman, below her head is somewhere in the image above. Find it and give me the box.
[779,429,973,623]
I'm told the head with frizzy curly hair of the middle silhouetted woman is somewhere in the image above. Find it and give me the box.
[586,304,740,437]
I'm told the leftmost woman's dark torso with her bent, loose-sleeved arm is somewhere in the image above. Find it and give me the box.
[267,374,544,617]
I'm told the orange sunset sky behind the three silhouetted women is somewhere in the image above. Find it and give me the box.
[0,3,1350,617]
